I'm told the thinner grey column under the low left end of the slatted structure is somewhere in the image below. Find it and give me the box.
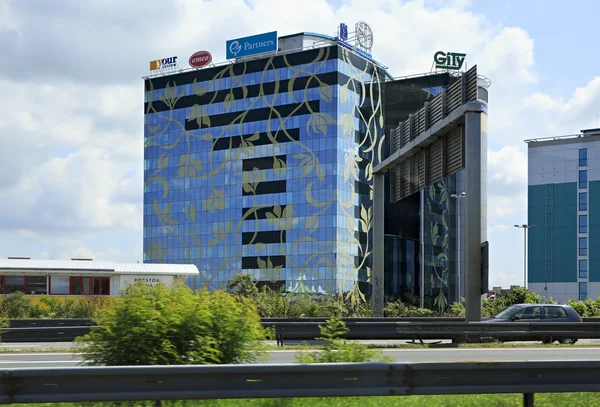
[371,174,385,318]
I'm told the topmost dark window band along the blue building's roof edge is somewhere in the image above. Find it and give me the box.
[144,45,385,91]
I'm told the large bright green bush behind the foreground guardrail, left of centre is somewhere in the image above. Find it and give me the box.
[77,282,265,366]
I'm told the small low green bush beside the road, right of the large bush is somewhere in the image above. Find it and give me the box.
[296,318,393,363]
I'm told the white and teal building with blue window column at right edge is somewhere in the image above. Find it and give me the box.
[526,129,600,303]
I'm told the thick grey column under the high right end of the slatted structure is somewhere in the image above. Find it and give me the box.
[464,112,487,322]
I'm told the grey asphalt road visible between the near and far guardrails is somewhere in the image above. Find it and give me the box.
[0,348,600,369]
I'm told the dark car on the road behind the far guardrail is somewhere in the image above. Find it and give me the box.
[482,304,583,344]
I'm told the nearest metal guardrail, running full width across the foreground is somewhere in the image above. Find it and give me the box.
[0,360,600,406]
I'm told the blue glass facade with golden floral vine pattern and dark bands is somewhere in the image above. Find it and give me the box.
[144,46,384,293]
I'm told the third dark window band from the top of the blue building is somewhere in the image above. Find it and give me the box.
[185,100,320,131]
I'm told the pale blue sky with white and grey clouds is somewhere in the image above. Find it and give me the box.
[0,0,600,288]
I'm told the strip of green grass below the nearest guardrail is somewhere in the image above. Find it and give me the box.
[8,393,600,407]
